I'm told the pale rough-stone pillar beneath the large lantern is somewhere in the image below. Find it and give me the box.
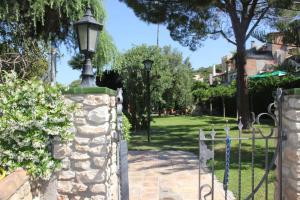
[54,90,118,200]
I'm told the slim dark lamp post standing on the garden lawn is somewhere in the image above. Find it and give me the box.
[143,59,153,142]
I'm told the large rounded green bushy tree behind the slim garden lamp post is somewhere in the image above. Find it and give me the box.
[117,45,192,129]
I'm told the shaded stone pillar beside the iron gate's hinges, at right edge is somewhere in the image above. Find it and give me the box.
[275,92,300,200]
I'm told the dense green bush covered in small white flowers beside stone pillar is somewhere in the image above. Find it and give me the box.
[0,72,74,179]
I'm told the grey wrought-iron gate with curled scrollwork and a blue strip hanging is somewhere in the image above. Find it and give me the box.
[198,89,286,200]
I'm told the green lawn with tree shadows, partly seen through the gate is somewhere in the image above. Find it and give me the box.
[129,116,275,200]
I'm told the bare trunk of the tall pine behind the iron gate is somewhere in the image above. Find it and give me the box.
[236,43,250,129]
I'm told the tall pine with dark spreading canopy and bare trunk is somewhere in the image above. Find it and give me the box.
[120,0,293,128]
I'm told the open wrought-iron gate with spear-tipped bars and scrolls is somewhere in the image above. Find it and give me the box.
[198,89,285,200]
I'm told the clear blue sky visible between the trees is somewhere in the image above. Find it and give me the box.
[57,0,253,84]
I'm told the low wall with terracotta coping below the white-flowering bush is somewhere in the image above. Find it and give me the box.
[0,169,32,200]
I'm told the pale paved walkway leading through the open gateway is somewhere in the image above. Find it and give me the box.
[128,151,234,200]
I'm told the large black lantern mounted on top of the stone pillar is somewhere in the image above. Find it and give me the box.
[74,7,103,87]
